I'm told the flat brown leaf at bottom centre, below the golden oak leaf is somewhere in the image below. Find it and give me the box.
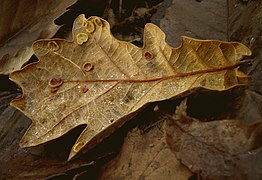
[99,128,192,179]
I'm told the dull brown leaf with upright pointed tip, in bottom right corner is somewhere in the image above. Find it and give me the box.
[163,101,262,179]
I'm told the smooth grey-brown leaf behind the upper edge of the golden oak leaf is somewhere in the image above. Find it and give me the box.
[158,0,229,46]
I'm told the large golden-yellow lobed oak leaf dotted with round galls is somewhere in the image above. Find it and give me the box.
[10,15,251,159]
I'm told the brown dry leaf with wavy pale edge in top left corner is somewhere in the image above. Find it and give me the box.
[0,0,76,74]
